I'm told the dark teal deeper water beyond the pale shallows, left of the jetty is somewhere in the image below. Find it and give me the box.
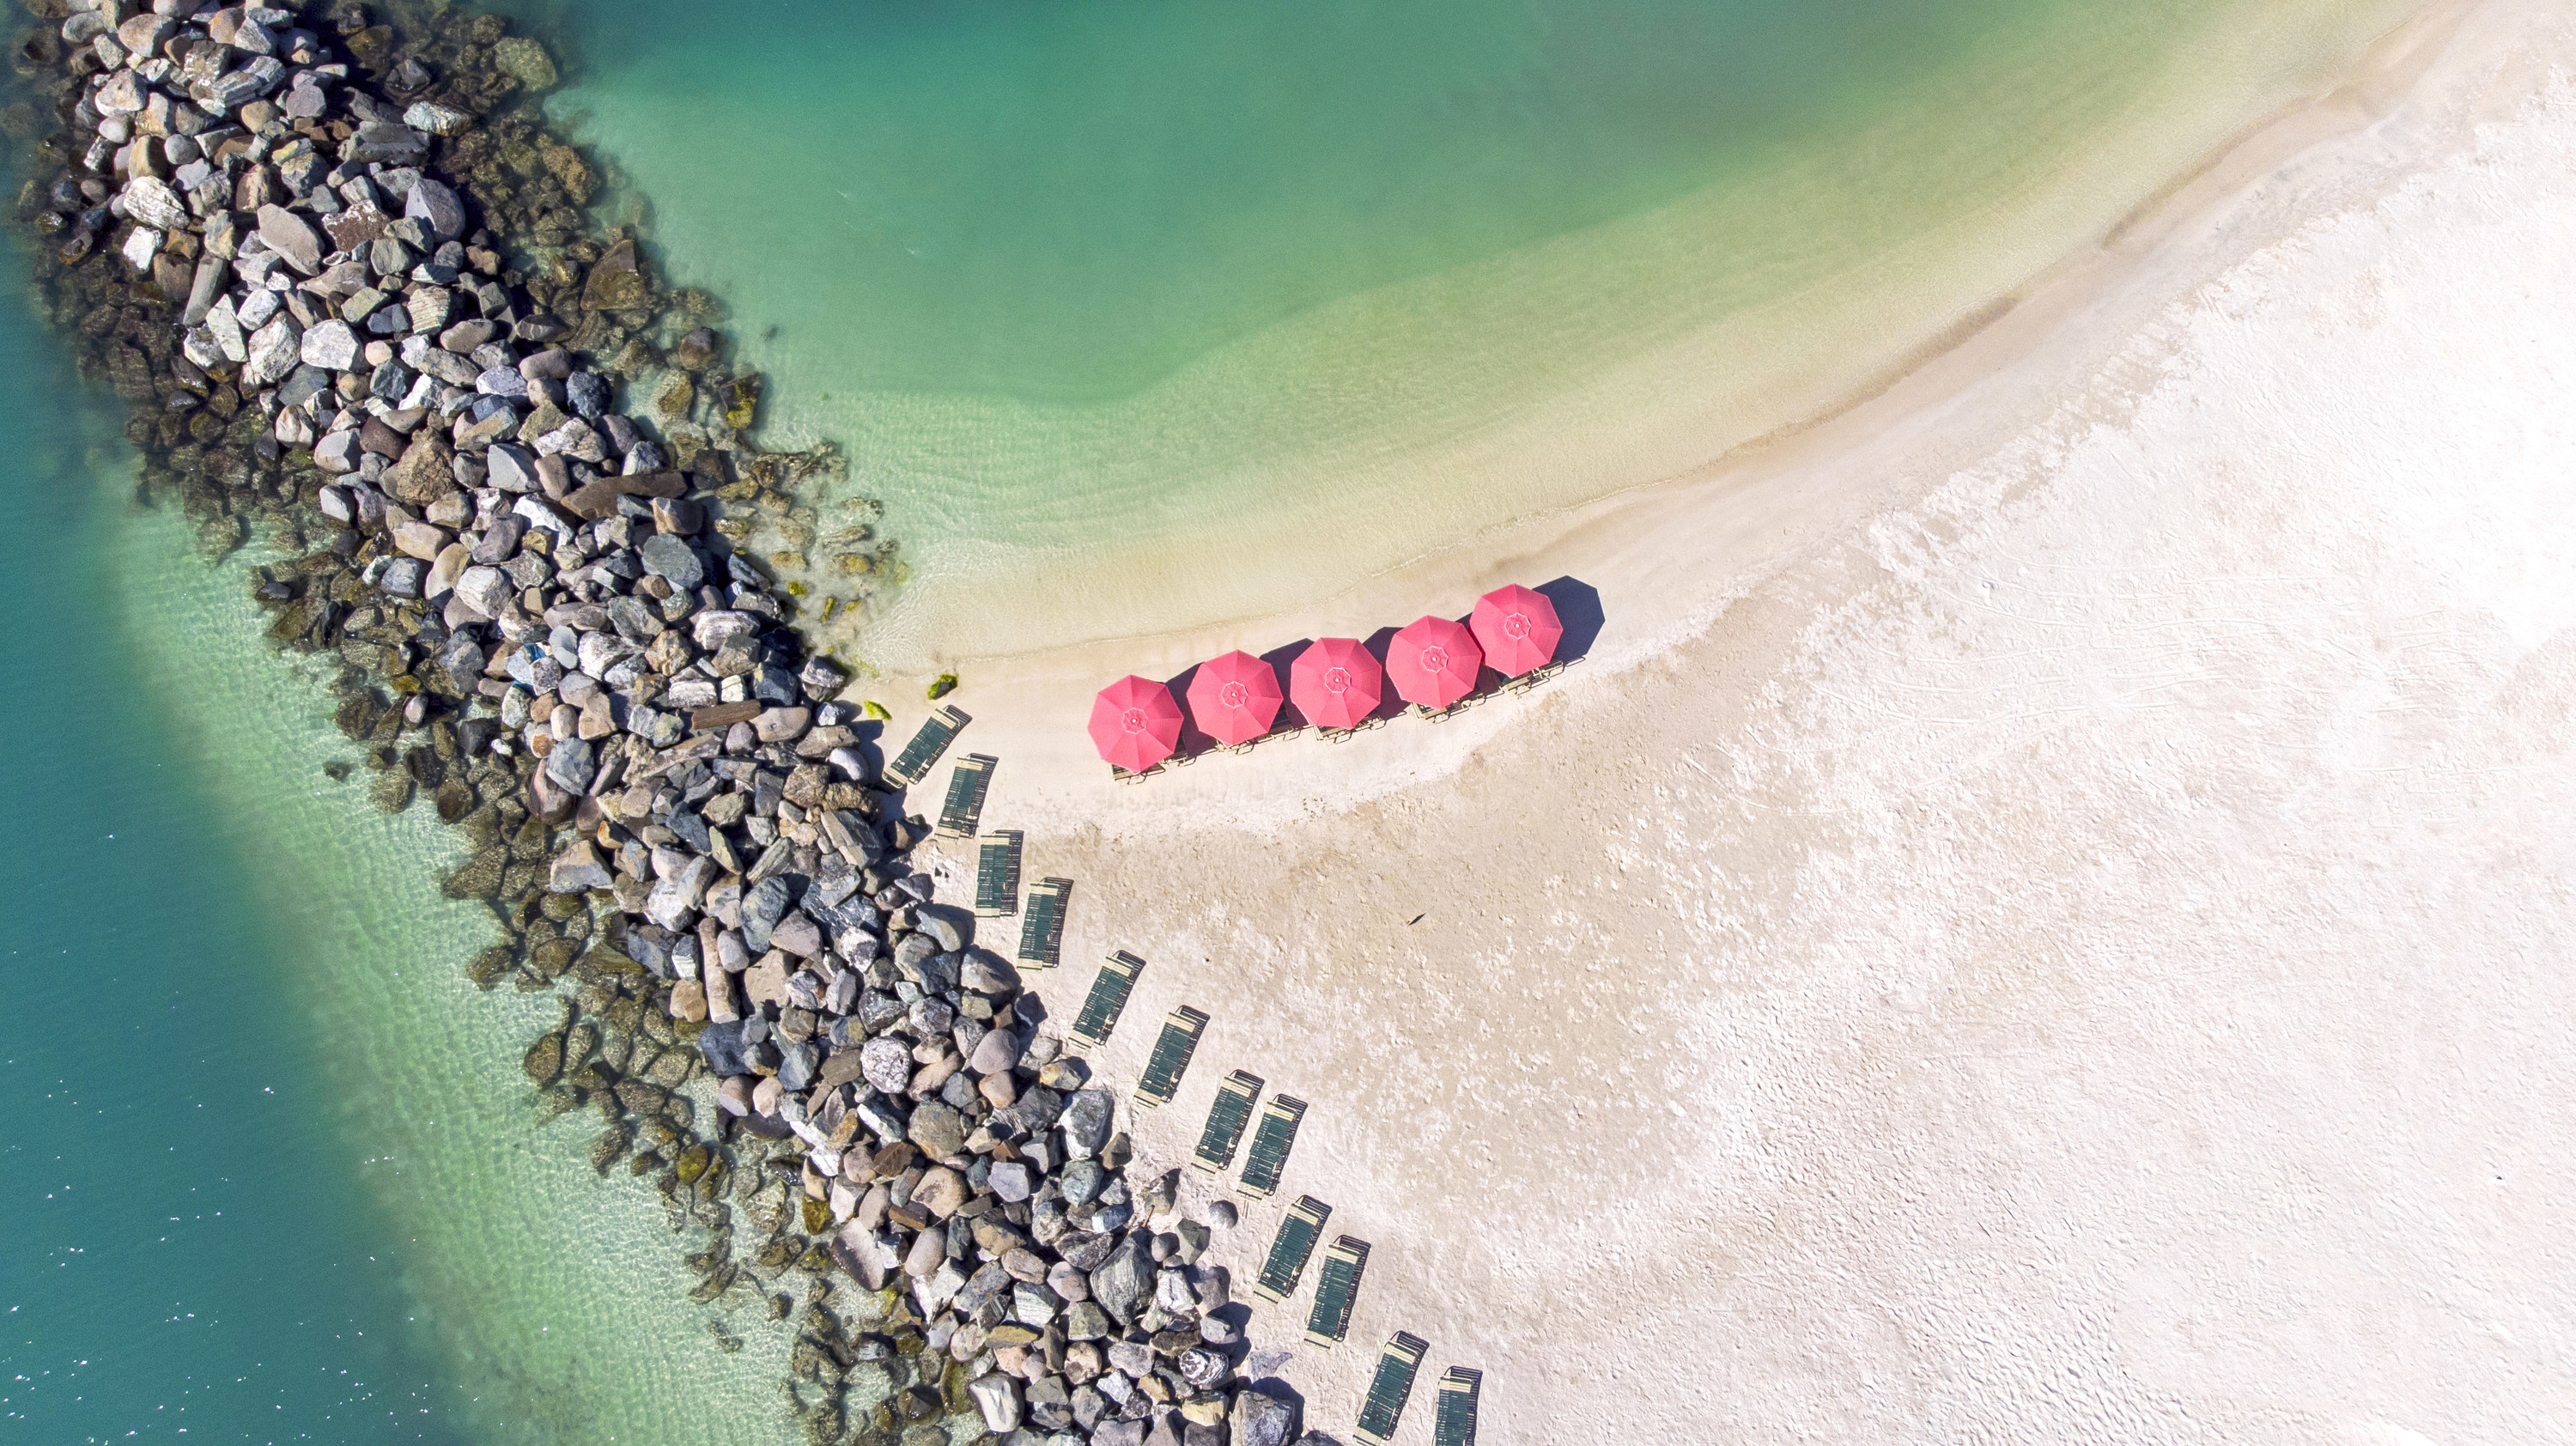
[0,279,461,1443]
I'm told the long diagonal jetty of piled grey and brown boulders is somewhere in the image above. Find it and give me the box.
[0,0,1298,1446]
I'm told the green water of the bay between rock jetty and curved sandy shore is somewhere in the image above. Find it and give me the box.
[518,0,2409,667]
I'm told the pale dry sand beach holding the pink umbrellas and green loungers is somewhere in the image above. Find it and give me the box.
[896,3,2576,1446]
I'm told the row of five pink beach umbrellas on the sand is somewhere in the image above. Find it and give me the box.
[1090,585,1566,774]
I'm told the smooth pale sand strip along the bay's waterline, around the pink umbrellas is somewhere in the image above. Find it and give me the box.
[917,0,2517,838]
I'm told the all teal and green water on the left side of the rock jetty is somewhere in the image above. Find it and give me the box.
[0,255,793,1446]
